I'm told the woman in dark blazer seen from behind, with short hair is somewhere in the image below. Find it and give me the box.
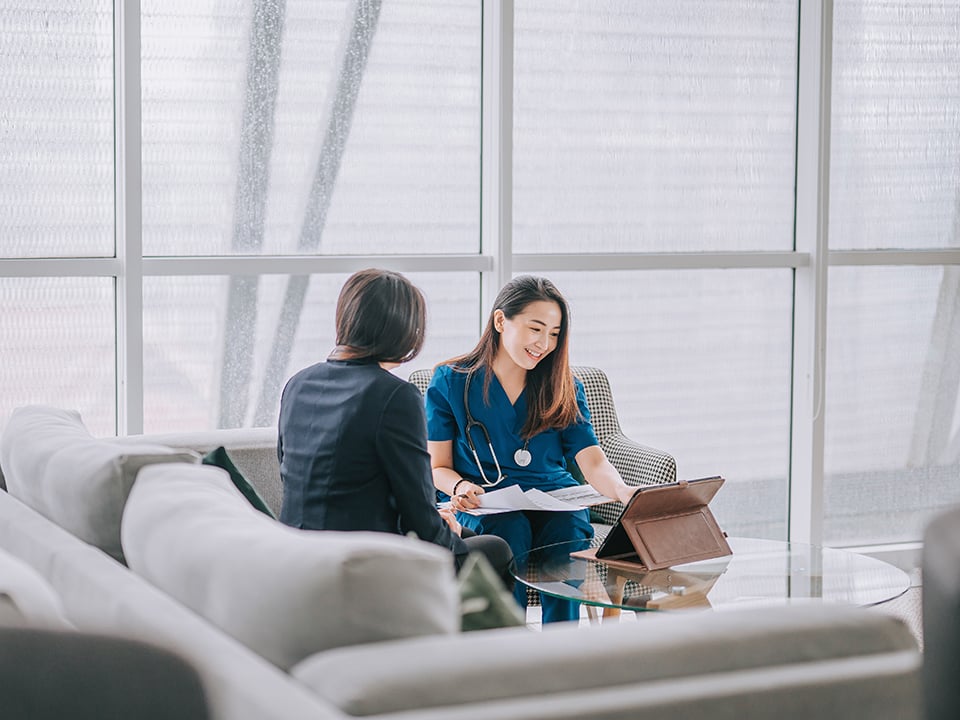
[277,270,513,587]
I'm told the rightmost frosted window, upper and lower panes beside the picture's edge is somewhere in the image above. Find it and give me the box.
[824,0,960,543]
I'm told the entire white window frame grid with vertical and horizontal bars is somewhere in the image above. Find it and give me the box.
[0,0,960,558]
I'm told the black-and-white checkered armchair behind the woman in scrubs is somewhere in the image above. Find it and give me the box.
[409,366,677,605]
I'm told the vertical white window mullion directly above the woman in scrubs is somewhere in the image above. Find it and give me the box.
[480,0,513,316]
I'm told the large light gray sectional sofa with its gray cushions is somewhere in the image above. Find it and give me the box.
[0,408,921,720]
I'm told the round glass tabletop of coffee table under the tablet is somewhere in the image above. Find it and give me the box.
[515,537,910,617]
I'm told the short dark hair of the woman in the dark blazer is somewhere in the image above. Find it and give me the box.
[336,268,427,363]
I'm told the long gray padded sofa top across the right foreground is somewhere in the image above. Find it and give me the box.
[291,605,919,717]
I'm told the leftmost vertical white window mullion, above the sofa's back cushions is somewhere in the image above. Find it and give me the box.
[114,0,143,435]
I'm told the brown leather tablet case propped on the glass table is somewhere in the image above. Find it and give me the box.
[571,476,732,570]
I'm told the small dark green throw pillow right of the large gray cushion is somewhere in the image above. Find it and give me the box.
[457,553,526,632]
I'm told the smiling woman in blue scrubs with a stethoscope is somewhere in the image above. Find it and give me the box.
[426,276,636,623]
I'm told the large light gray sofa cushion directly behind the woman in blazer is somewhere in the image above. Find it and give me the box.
[121,465,459,669]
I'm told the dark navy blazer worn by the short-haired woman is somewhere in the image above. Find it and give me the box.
[277,360,467,554]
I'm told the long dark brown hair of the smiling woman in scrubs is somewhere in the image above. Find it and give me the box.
[441,275,580,438]
